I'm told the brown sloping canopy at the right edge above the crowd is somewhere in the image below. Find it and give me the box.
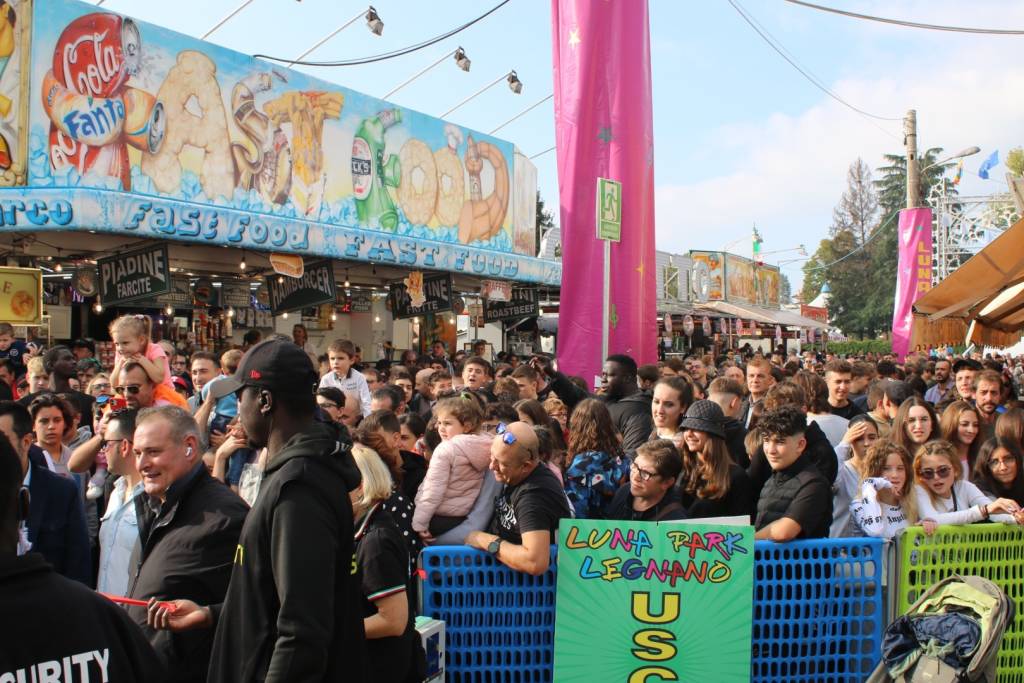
[910,219,1024,348]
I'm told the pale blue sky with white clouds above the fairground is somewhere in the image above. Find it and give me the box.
[86,0,1024,291]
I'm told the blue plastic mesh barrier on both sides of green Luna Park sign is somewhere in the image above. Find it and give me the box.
[420,539,883,683]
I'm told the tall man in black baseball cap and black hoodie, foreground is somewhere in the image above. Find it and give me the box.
[150,339,366,682]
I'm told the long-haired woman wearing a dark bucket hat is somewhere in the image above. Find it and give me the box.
[677,400,754,519]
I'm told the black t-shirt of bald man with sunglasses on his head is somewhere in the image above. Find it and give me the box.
[487,463,572,545]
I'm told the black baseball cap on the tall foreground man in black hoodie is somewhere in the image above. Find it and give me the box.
[210,339,319,398]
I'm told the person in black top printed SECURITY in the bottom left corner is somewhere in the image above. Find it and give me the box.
[0,419,164,683]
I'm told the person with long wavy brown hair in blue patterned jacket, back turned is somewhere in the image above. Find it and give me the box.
[565,398,629,519]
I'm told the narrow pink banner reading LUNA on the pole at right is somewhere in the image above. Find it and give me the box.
[893,209,932,360]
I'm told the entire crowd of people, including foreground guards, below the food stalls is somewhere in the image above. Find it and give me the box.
[0,316,1024,683]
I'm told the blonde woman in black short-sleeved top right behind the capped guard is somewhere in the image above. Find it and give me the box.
[349,443,422,683]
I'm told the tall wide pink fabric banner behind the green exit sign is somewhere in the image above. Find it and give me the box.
[551,0,657,382]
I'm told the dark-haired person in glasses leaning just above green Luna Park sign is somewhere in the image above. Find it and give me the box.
[605,438,686,521]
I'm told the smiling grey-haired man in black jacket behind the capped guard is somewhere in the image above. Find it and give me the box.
[128,405,248,683]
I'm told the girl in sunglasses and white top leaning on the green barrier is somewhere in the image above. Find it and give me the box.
[913,440,1024,535]
